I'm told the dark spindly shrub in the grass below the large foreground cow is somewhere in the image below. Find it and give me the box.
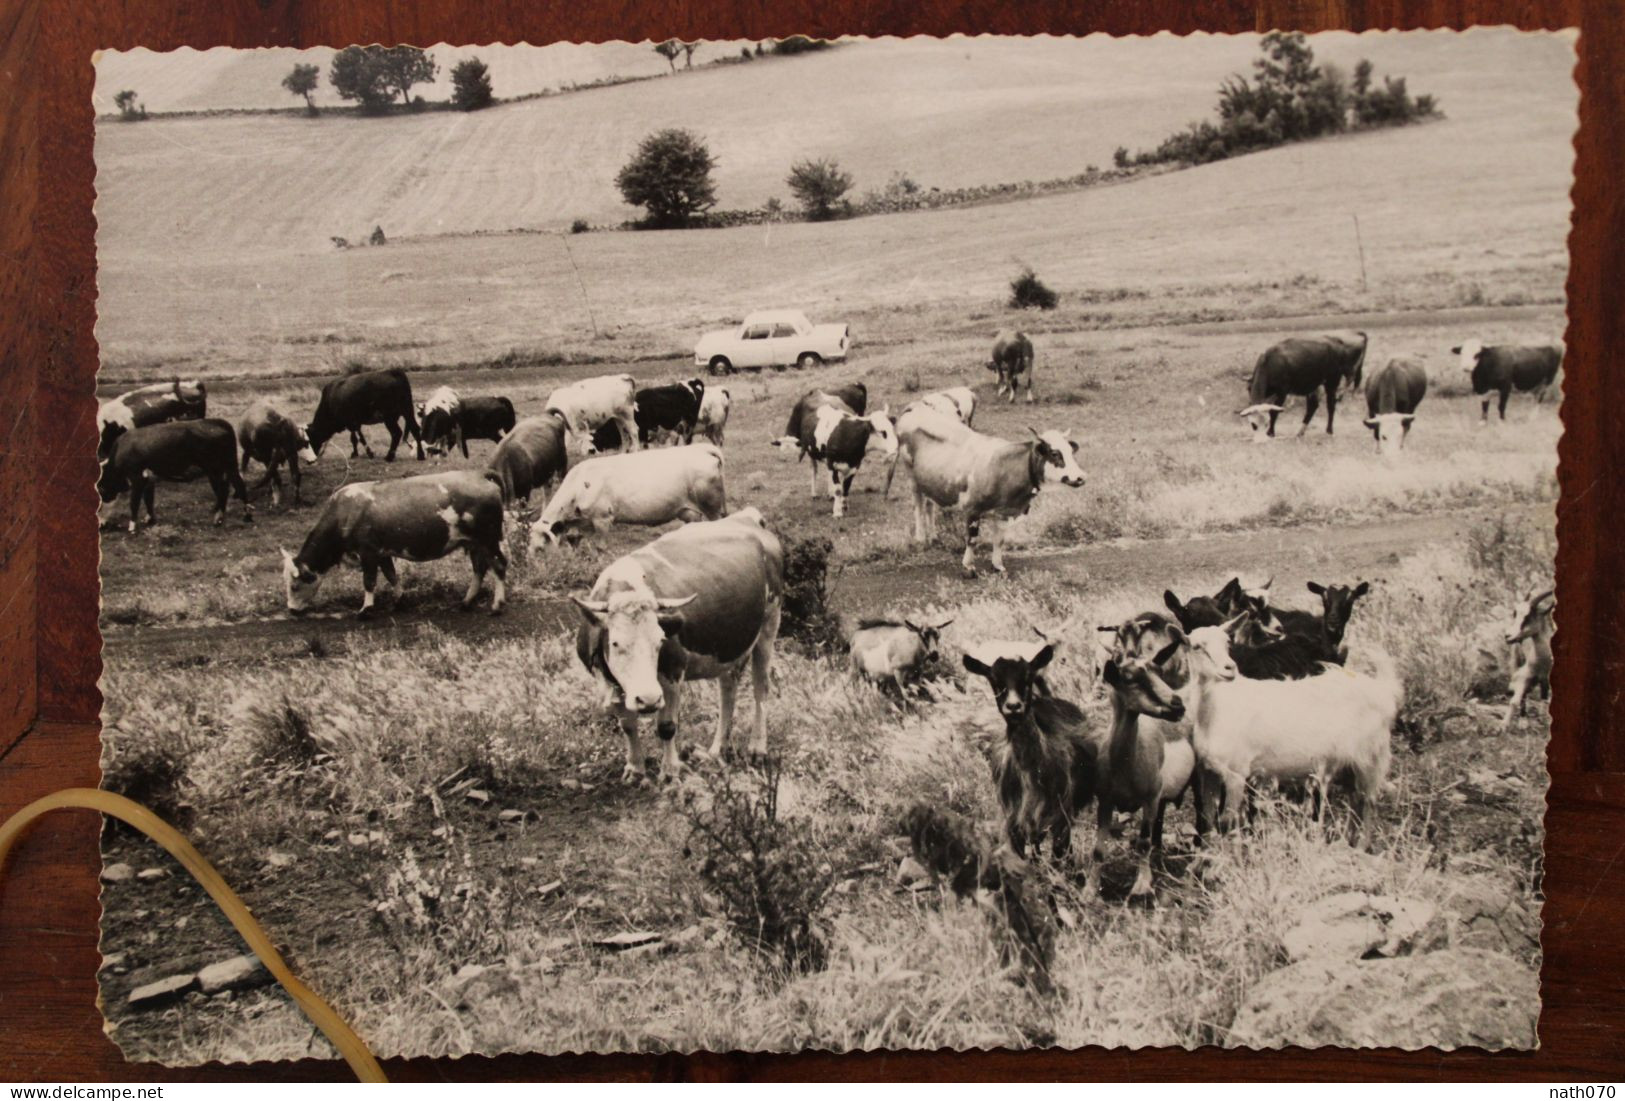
[684,758,835,974]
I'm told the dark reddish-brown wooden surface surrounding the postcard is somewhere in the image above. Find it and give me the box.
[0,0,1625,1082]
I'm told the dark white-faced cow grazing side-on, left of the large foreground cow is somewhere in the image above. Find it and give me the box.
[283,471,507,617]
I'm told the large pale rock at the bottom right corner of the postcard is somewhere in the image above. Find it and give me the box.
[1230,948,1541,1051]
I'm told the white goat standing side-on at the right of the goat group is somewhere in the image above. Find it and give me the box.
[1183,627,1404,848]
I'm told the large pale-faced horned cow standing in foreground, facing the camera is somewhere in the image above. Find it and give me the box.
[570,508,785,783]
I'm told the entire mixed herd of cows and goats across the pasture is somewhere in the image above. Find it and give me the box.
[99,333,1562,895]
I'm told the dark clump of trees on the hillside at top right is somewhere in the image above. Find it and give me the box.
[1115,31,1440,169]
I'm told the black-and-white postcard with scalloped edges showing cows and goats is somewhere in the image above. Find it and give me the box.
[96,29,1578,1064]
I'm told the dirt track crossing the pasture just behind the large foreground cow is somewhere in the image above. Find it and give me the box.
[102,505,1549,666]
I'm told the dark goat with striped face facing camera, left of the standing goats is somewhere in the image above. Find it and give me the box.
[964,643,1100,861]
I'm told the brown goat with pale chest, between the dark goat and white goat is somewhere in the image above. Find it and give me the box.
[1089,633,1196,898]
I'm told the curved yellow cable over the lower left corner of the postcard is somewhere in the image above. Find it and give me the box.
[0,788,388,1082]
